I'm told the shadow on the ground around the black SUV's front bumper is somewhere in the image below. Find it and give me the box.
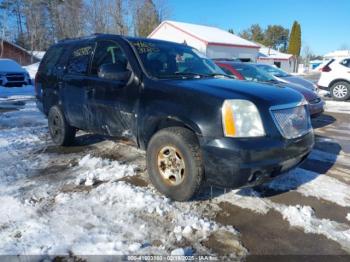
[195,135,342,200]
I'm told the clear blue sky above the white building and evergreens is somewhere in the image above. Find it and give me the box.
[168,0,350,55]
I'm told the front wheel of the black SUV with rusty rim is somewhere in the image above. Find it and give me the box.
[147,127,204,201]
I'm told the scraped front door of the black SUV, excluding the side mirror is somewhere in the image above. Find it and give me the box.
[87,40,139,142]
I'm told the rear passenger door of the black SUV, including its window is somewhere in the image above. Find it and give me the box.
[59,42,93,130]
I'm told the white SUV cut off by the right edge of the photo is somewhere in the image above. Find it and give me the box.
[318,57,350,101]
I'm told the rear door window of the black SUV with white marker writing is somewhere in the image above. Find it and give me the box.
[67,45,92,75]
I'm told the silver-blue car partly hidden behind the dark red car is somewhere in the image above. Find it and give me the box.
[256,63,317,92]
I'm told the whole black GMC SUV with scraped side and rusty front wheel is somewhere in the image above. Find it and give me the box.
[35,35,314,201]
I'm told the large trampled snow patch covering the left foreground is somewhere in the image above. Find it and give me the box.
[0,89,247,255]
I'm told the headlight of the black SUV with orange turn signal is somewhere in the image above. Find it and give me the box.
[222,99,265,137]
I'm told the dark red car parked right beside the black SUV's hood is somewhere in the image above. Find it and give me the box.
[215,60,324,117]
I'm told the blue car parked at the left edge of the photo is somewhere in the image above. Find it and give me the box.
[0,59,31,87]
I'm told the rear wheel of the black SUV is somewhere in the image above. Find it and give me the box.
[48,106,76,146]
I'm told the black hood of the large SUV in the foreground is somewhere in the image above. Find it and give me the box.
[170,78,302,106]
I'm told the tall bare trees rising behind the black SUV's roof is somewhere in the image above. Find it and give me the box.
[0,0,169,50]
